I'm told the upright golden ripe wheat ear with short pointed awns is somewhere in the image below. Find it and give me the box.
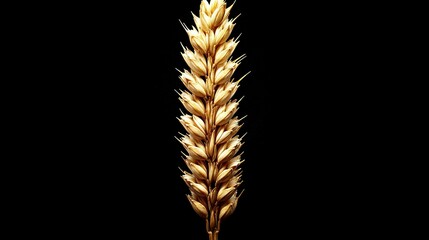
[178,0,247,240]
